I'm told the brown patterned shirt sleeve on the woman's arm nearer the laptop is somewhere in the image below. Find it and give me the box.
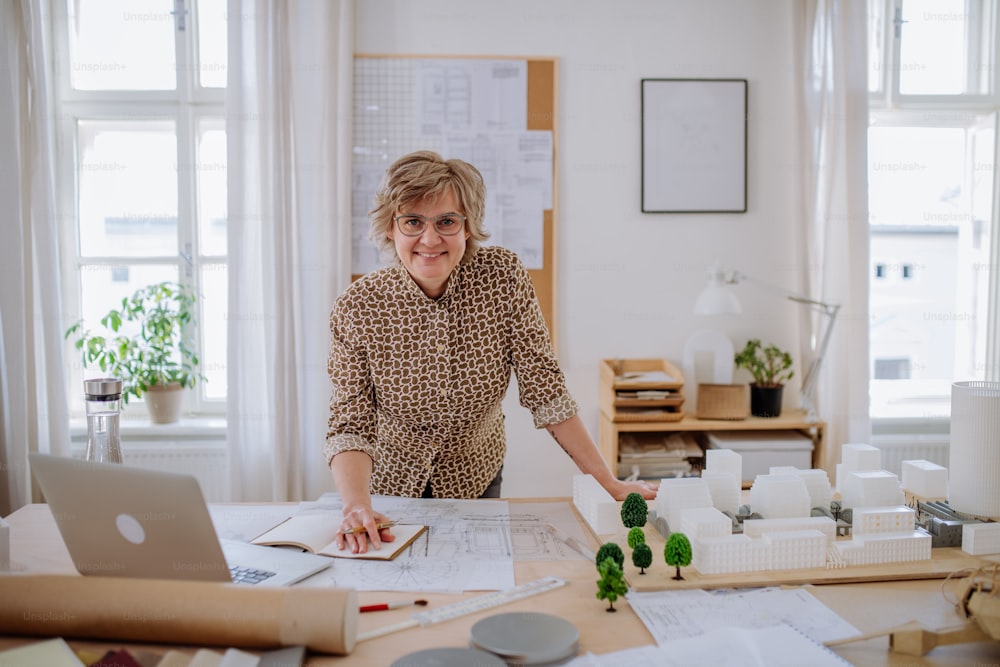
[324,300,376,465]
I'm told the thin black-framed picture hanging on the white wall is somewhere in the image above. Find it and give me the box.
[642,79,747,213]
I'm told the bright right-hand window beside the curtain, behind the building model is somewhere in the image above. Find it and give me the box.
[868,0,1000,419]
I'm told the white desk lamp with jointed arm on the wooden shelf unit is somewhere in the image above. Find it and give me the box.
[694,264,840,421]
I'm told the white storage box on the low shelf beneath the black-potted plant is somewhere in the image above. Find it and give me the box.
[705,431,813,484]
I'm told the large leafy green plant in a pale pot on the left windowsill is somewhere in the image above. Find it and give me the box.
[66,281,205,424]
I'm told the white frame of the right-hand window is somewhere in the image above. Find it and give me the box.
[868,0,1000,435]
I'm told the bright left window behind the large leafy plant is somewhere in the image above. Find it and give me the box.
[53,0,227,414]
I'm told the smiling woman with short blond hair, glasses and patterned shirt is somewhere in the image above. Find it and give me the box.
[325,151,656,552]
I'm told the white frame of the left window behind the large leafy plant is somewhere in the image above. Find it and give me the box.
[51,0,227,418]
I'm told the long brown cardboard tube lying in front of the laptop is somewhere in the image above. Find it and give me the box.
[0,575,358,655]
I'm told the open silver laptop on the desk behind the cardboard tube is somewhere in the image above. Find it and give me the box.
[28,453,333,586]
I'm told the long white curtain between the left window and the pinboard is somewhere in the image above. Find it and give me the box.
[226,0,354,501]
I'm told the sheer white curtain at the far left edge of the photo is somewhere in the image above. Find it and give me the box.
[0,0,69,516]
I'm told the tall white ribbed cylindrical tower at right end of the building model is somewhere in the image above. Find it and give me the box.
[948,381,1000,519]
